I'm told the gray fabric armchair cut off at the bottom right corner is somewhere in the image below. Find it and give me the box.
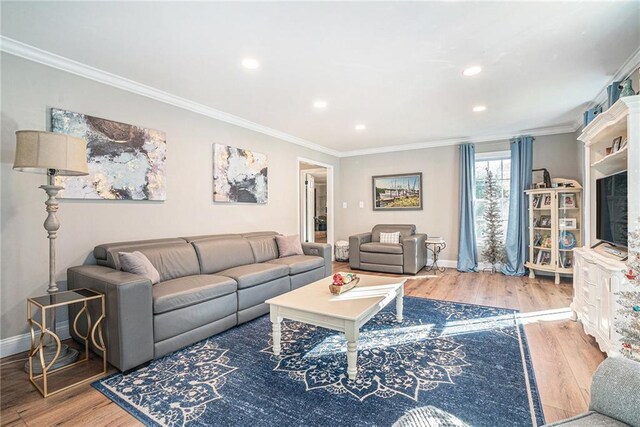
[547,356,640,427]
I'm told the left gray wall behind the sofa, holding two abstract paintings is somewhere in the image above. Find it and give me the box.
[0,54,339,338]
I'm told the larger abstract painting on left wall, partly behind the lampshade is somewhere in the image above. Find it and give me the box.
[51,108,167,200]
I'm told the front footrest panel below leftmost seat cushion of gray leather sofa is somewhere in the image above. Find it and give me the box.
[153,292,238,342]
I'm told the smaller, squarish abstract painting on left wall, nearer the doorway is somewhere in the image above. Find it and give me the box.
[213,144,268,203]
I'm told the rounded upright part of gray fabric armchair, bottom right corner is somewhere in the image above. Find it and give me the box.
[589,356,640,426]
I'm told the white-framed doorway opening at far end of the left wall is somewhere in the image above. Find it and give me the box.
[298,159,334,249]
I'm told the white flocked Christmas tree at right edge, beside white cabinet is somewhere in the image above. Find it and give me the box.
[615,218,640,361]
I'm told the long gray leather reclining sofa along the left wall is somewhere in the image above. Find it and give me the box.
[67,232,332,371]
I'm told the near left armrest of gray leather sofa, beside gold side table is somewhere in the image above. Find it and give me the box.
[67,265,154,371]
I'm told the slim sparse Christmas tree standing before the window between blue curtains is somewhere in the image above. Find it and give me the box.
[482,168,504,273]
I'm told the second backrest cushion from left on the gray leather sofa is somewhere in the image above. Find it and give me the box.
[192,237,255,274]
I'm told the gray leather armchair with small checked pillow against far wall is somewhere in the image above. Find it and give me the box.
[349,224,427,274]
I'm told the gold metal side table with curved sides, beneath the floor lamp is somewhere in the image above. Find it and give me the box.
[27,289,107,397]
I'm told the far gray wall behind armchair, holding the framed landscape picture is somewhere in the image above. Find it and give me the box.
[335,133,582,260]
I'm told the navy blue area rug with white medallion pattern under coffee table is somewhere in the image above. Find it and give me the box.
[93,297,544,427]
